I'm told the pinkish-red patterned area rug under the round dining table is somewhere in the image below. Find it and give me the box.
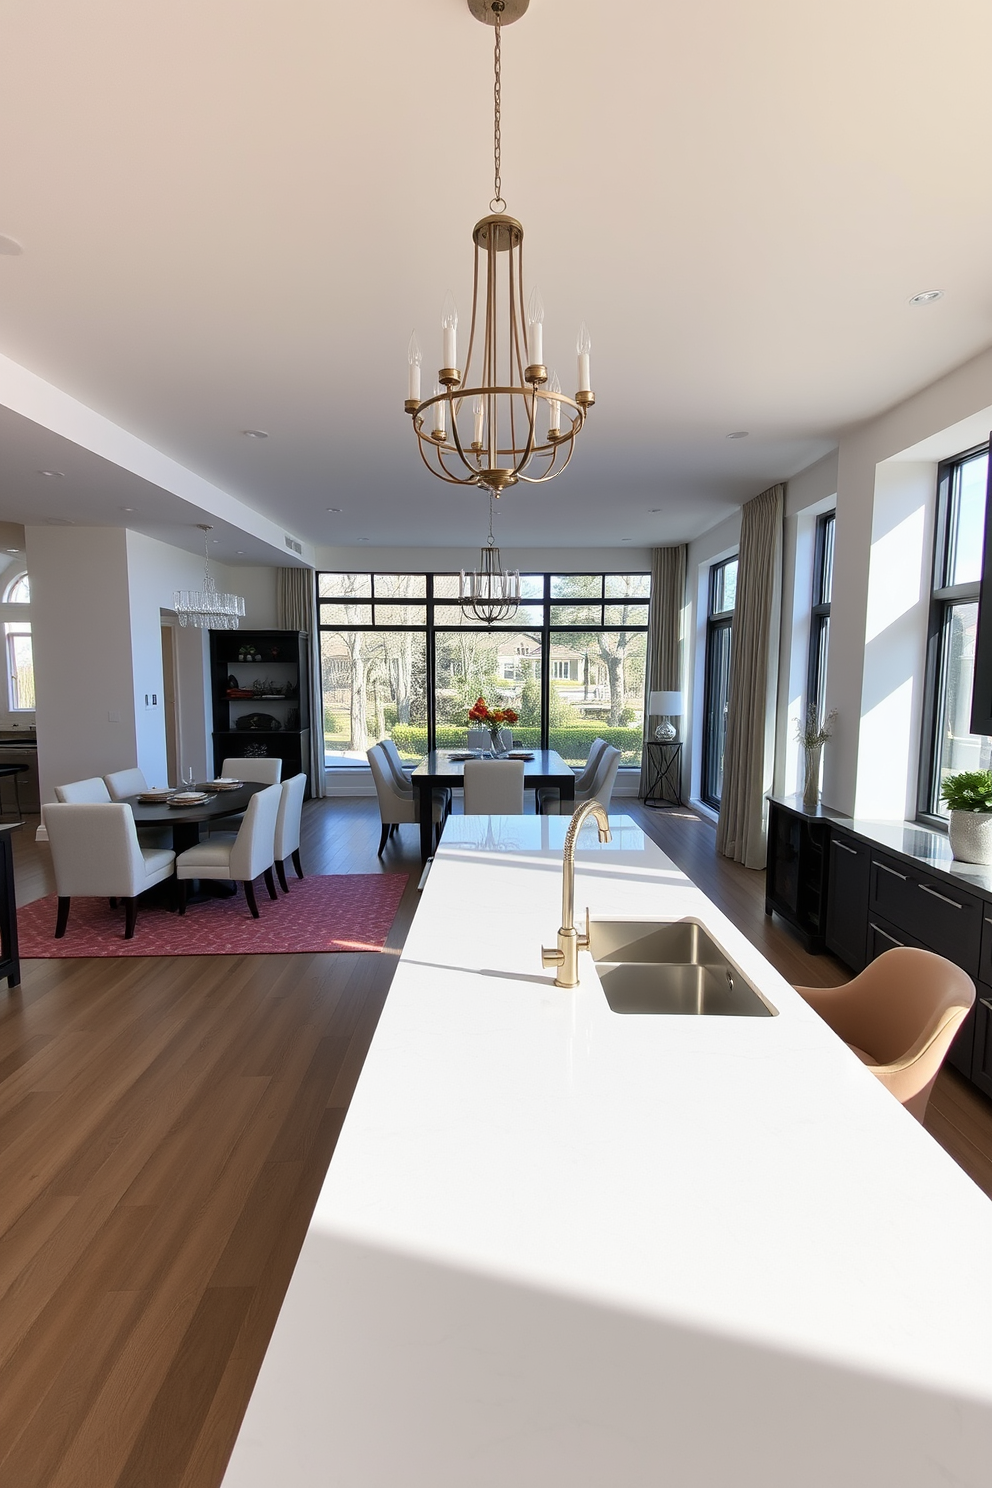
[18,873,408,960]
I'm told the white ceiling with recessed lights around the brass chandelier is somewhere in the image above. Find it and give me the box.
[0,0,992,561]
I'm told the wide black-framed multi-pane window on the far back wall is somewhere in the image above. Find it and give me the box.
[317,573,651,766]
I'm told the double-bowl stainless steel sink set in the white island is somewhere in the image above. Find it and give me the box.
[589,920,778,1018]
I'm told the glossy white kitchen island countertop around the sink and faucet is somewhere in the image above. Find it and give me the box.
[225,815,992,1488]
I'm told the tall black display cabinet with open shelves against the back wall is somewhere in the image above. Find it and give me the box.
[210,631,311,795]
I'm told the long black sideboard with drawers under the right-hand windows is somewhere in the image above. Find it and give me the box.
[764,796,992,1095]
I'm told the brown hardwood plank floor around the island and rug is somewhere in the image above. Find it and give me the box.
[0,799,992,1488]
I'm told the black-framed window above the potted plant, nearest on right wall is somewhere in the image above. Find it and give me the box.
[919,445,992,821]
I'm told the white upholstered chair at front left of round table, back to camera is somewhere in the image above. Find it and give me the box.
[45,803,175,940]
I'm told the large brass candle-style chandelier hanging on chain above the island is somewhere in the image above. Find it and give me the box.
[405,0,596,497]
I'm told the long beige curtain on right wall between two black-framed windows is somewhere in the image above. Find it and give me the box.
[717,485,785,868]
